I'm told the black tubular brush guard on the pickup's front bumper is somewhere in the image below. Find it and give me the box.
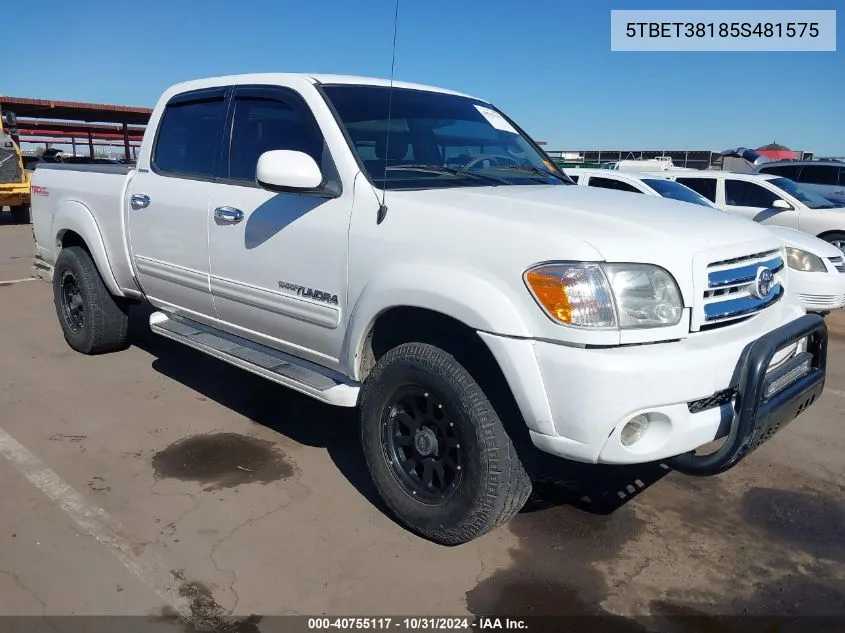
[666,314,827,476]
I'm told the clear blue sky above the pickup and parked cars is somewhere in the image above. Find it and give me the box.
[8,0,845,156]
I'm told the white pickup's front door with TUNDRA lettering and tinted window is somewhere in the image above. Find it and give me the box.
[208,86,352,366]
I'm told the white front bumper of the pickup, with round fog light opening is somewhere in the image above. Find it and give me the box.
[481,309,827,474]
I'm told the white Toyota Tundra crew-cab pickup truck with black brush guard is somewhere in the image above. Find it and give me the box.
[33,74,827,544]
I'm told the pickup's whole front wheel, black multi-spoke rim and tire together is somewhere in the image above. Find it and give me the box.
[361,343,531,545]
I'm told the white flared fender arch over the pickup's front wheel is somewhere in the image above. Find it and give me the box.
[340,264,531,380]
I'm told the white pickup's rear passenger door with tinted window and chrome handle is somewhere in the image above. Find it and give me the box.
[127,88,226,325]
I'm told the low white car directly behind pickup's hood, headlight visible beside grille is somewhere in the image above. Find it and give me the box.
[564,169,845,313]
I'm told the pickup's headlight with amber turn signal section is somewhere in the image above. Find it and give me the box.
[525,263,683,329]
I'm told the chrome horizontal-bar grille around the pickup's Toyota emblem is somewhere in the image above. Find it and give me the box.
[704,250,785,325]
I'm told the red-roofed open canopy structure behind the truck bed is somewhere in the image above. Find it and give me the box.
[0,97,152,160]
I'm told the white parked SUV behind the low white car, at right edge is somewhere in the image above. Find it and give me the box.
[640,171,845,251]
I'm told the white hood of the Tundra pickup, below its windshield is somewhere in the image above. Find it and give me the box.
[387,185,779,262]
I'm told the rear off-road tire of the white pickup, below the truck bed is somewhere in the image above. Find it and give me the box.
[53,246,129,354]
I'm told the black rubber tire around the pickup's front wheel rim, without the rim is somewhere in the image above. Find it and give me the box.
[360,343,531,545]
